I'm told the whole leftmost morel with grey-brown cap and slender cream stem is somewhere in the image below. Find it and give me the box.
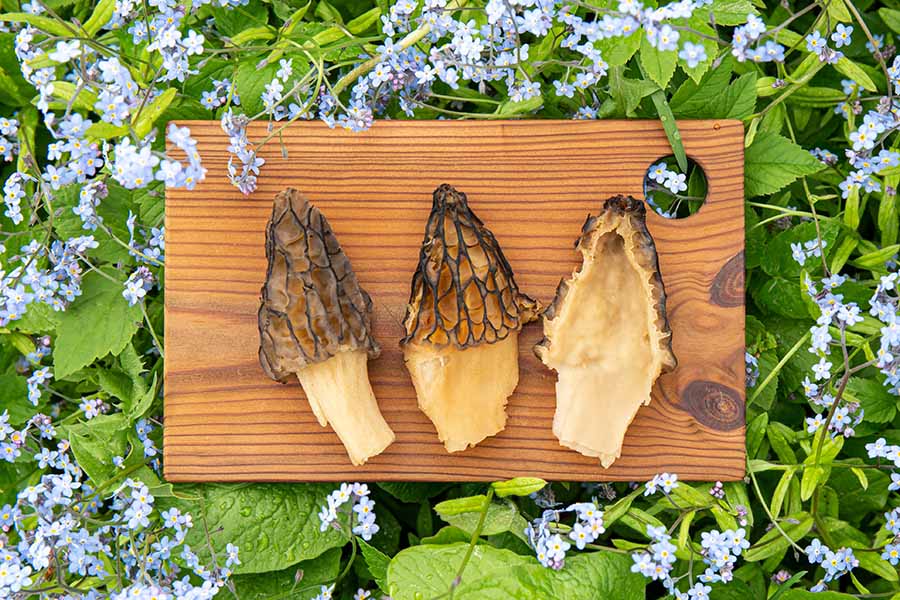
[259,189,394,465]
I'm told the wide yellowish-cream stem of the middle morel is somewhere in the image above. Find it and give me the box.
[404,332,519,452]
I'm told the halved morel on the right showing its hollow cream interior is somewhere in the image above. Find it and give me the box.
[535,196,676,467]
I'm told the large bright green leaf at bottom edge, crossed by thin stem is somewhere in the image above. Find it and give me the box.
[388,544,645,600]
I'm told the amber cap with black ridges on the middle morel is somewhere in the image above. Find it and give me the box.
[400,183,538,349]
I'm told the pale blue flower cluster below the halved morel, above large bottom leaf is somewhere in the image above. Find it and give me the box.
[525,502,606,570]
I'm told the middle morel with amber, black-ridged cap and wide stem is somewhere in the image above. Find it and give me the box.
[400,184,537,452]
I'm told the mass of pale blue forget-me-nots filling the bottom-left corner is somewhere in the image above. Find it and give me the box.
[0,412,240,599]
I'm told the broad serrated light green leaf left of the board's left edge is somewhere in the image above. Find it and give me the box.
[53,273,141,379]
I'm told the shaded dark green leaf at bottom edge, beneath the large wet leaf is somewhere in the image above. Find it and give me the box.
[232,542,342,600]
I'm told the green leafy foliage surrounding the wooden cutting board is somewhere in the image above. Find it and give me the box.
[0,0,900,600]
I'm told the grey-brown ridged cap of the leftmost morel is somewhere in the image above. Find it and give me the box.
[258,188,380,381]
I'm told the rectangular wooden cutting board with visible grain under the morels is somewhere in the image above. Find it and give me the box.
[164,121,745,481]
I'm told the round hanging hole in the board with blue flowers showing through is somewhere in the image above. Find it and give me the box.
[644,155,708,219]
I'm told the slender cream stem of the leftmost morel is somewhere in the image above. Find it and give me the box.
[297,350,394,465]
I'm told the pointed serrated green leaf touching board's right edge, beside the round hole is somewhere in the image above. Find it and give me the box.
[744,131,823,197]
